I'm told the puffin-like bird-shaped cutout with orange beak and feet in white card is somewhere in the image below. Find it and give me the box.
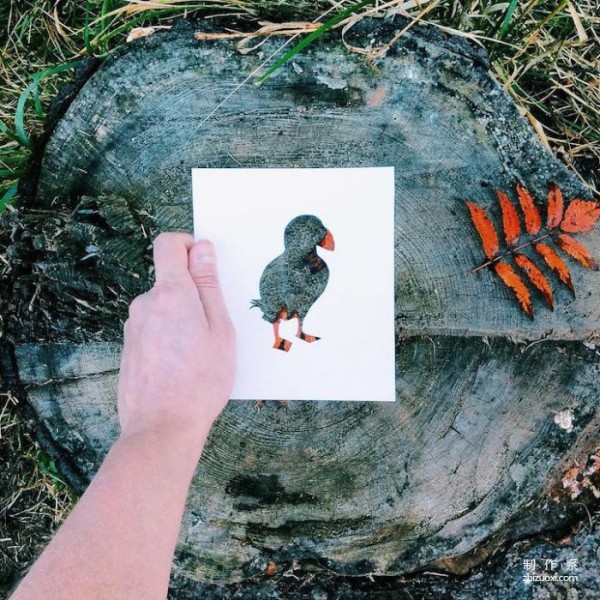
[250,215,334,352]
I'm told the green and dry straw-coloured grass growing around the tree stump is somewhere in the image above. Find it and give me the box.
[0,0,600,591]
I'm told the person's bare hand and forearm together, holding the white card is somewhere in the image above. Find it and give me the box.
[11,233,235,600]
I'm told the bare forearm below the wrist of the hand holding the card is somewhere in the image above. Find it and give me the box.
[13,425,208,600]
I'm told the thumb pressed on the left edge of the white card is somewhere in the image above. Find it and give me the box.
[188,240,229,327]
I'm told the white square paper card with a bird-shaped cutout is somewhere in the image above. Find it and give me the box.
[192,167,395,402]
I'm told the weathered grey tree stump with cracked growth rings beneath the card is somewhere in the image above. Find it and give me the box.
[3,16,600,583]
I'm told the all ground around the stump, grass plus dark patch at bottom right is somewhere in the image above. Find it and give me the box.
[0,0,600,598]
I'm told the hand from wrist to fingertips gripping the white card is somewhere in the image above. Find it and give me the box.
[118,233,235,446]
